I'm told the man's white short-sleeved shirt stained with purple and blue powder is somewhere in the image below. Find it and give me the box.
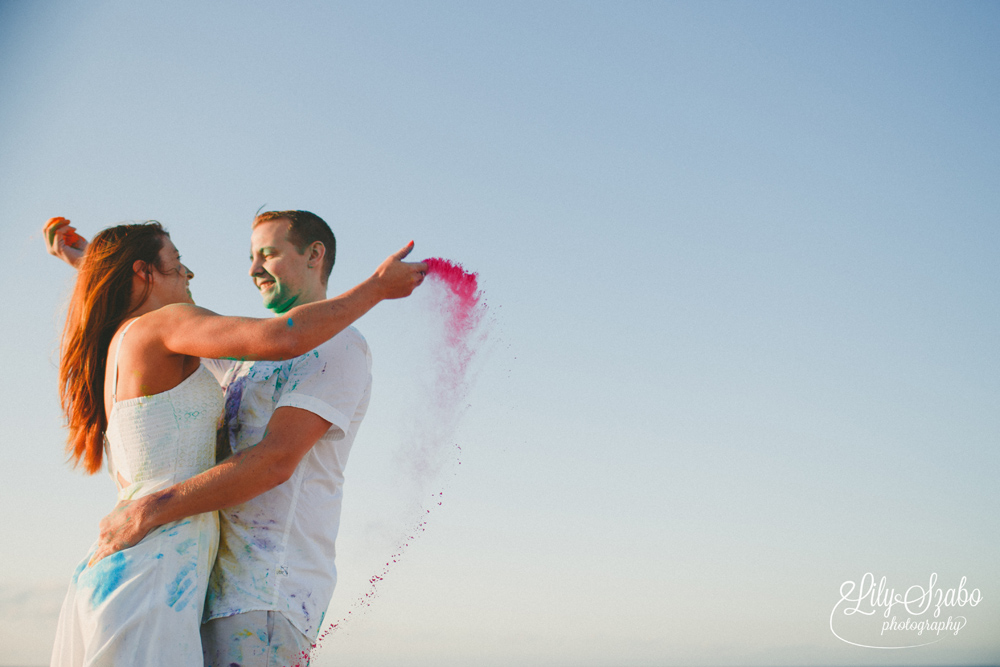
[202,327,372,638]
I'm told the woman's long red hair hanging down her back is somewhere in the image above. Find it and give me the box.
[59,222,167,475]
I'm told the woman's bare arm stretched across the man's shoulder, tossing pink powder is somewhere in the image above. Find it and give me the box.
[144,241,427,361]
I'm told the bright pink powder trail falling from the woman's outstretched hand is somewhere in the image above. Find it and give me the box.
[314,257,487,650]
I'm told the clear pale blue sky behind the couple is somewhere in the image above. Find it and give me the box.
[0,2,1000,667]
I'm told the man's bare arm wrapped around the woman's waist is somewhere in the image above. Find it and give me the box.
[90,406,330,565]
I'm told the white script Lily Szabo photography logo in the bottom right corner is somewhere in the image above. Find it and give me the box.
[830,572,983,649]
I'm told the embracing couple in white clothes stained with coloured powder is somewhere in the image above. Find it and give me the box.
[46,211,427,667]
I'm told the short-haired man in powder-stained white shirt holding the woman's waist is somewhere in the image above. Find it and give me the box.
[47,211,426,667]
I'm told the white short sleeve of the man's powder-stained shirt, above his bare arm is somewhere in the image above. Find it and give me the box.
[275,328,371,440]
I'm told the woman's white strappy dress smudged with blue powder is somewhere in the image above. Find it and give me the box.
[51,324,223,667]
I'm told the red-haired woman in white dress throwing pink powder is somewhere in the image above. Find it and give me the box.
[47,219,425,666]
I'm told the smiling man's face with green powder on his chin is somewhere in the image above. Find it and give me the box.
[250,220,308,314]
